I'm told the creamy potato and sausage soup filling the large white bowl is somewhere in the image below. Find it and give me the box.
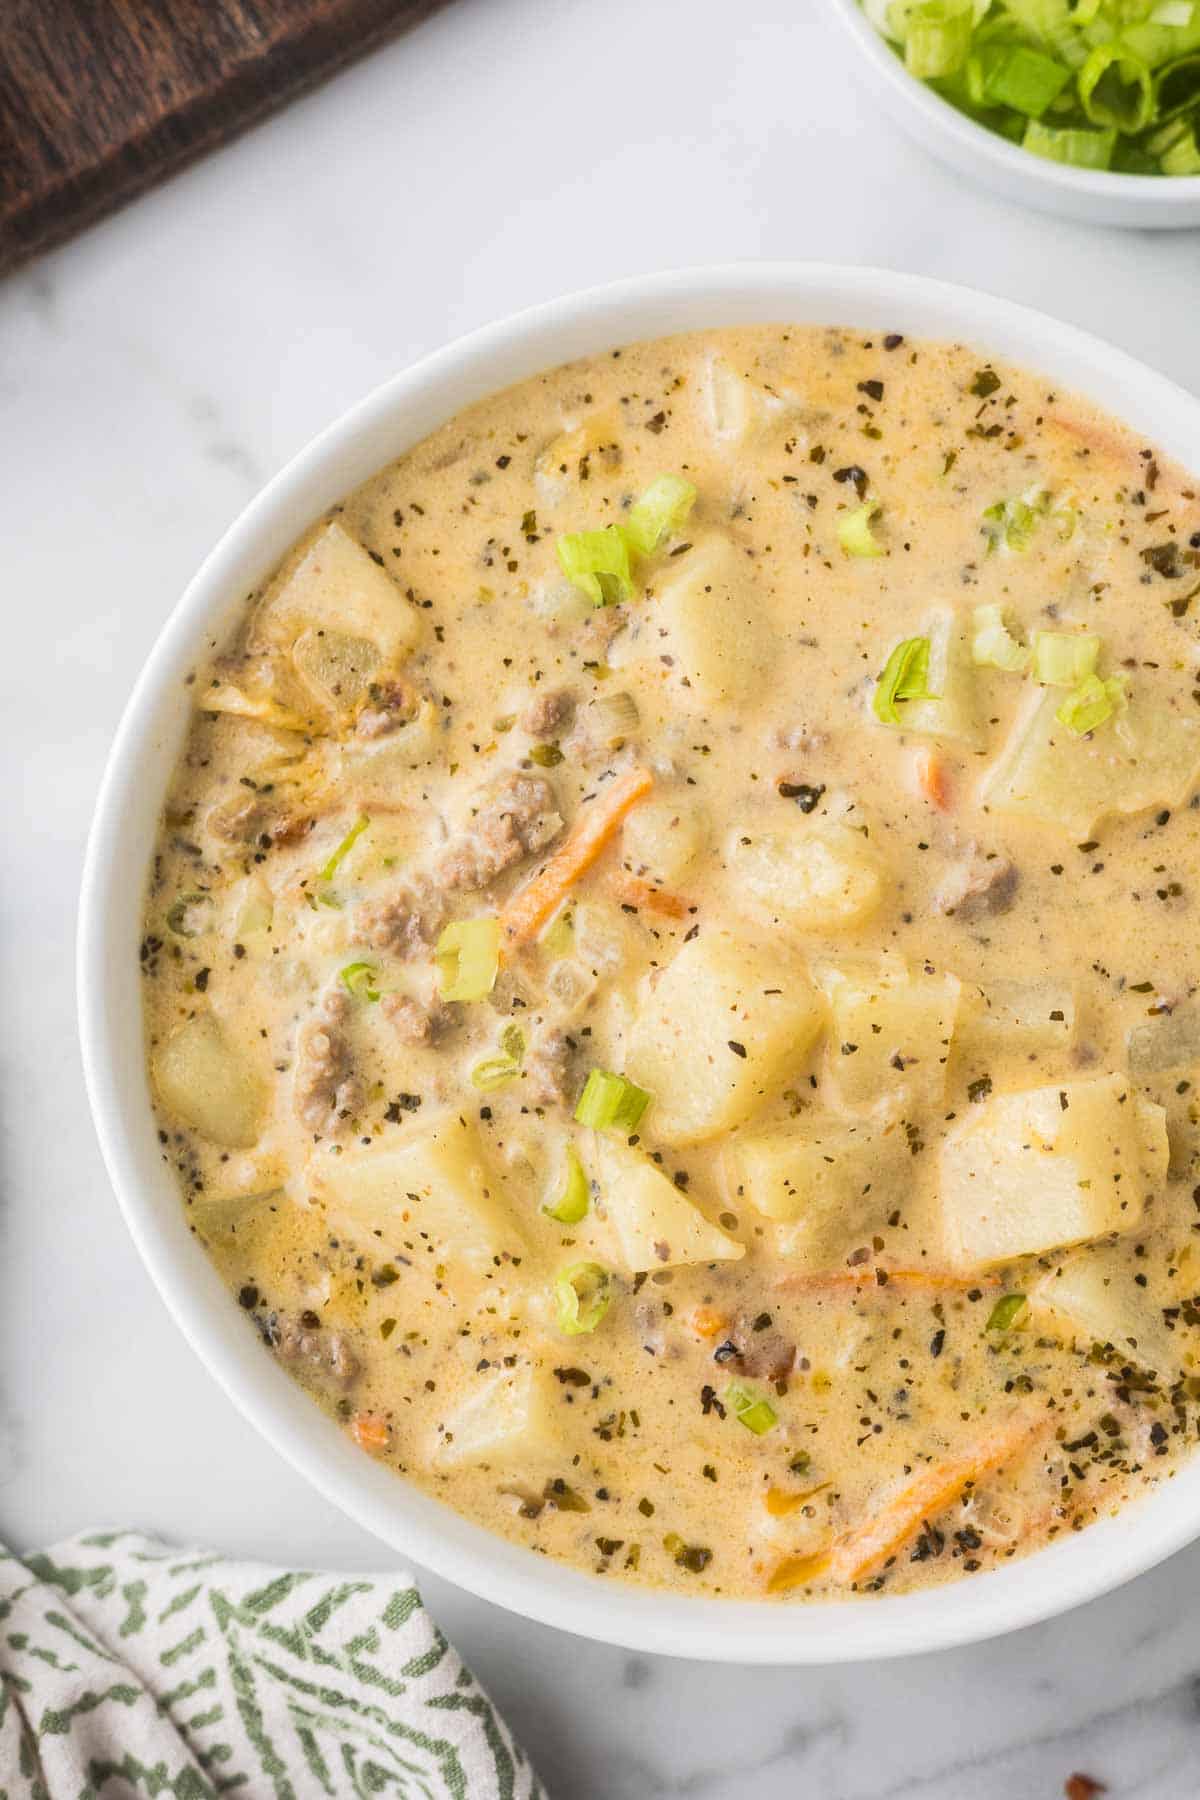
[142,326,1200,1600]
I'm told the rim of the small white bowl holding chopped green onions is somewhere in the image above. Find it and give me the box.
[829,0,1200,202]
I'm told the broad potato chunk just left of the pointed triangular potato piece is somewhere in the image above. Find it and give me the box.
[308,1112,525,1271]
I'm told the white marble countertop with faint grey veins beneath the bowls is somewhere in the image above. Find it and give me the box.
[0,0,1200,1800]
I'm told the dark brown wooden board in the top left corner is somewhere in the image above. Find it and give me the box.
[0,0,449,274]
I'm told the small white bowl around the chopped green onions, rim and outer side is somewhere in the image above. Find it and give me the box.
[829,0,1200,230]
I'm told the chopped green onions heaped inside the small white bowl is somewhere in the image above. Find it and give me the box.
[862,0,1200,178]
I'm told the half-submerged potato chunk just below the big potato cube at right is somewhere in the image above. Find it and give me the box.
[1029,1244,1187,1382]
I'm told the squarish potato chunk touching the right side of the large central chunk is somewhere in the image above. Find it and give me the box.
[819,958,961,1107]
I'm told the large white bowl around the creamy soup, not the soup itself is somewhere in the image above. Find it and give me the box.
[79,263,1200,1663]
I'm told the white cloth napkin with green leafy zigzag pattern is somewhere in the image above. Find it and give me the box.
[0,1532,545,1800]
